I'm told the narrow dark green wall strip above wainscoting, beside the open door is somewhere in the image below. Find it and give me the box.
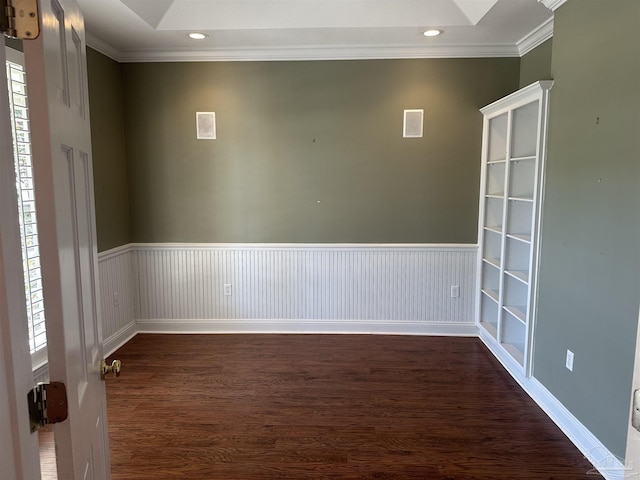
[87,48,131,252]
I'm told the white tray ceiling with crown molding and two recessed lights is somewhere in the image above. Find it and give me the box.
[78,0,553,62]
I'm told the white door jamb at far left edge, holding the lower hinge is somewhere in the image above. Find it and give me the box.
[0,42,40,480]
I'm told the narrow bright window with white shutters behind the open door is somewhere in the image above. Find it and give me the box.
[6,49,47,365]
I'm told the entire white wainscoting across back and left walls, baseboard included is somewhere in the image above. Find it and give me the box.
[99,244,477,344]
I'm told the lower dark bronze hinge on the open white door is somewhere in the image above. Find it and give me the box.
[27,382,68,433]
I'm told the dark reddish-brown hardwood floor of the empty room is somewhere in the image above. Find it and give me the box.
[107,334,602,480]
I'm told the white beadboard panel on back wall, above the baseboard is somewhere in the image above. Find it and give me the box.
[130,244,477,333]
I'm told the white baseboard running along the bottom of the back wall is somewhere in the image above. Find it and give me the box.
[136,319,478,337]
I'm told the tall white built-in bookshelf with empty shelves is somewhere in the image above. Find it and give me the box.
[476,81,553,375]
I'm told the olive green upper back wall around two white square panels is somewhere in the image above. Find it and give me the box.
[122,58,520,243]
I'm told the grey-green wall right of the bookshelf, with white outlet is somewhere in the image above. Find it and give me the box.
[534,0,640,458]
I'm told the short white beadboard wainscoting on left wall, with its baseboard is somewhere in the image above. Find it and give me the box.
[98,245,136,356]
